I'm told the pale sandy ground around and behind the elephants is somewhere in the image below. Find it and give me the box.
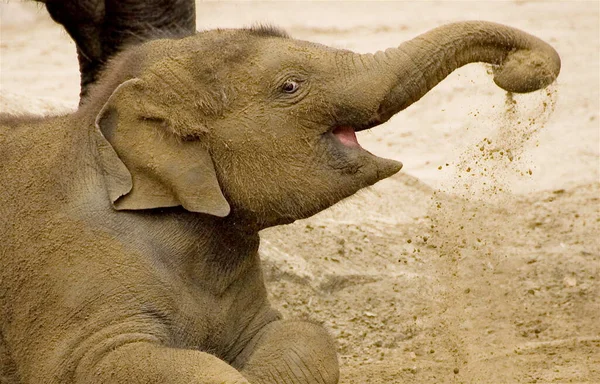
[0,1,600,384]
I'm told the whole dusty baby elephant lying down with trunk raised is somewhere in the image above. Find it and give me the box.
[0,22,560,384]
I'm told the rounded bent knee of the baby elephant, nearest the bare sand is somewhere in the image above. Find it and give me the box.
[233,321,339,384]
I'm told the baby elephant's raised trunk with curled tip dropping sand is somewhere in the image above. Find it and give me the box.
[361,21,560,126]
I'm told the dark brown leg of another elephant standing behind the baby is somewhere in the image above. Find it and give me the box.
[36,0,196,98]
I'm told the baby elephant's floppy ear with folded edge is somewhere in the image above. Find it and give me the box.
[96,79,230,217]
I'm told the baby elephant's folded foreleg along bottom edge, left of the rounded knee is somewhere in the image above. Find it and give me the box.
[76,342,249,384]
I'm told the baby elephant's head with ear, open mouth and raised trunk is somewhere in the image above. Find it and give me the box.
[86,22,560,229]
